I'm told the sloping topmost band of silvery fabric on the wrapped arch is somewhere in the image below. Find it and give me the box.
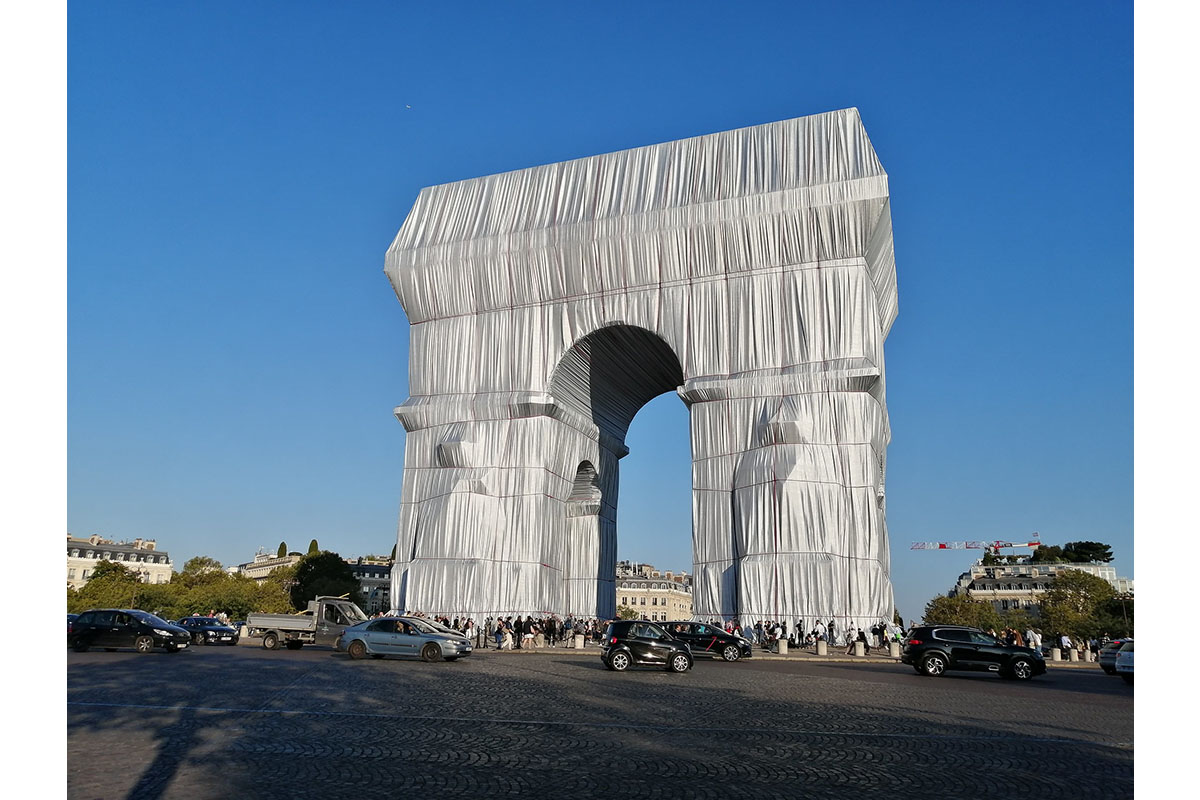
[390,108,887,251]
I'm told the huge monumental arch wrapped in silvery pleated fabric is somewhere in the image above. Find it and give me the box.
[386,109,896,625]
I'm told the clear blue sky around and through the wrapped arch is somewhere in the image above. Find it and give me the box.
[67,2,1134,618]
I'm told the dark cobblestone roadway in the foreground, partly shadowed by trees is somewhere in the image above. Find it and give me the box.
[67,646,1133,800]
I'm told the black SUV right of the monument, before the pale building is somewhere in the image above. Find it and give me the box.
[900,625,1046,680]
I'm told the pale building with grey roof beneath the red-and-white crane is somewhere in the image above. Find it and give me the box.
[947,557,1133,613]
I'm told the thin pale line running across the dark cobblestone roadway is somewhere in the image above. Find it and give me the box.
[67,700,1133,750]
